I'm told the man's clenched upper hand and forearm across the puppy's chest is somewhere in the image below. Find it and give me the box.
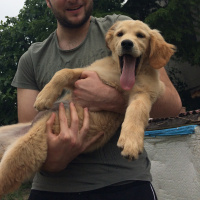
[73,71,126,114]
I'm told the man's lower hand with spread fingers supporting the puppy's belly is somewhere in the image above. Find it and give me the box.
[42,103,103,172]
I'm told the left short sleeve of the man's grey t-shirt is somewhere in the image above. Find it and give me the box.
[11,51,39,90]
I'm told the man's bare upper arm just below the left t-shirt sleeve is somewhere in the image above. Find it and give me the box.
[17,88,39,123]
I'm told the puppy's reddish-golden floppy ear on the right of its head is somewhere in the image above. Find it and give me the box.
[149,30,176,69]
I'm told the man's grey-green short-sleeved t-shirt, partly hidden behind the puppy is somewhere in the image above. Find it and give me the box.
[12,15,151,192]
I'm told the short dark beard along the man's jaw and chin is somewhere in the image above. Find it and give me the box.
[49,1,93,28]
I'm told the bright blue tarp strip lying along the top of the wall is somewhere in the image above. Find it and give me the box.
[145,125,198,137]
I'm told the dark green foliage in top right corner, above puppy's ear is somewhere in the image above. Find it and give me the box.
[145,0,200,65]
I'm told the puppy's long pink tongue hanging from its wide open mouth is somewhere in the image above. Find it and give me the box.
[120,55,136,90]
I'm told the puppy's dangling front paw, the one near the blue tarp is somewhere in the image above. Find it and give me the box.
[117,130,144,160]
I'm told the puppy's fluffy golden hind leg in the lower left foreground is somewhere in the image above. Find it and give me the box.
[0,116,47,196]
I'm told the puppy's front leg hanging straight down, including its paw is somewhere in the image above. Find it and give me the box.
[117,93,152,159]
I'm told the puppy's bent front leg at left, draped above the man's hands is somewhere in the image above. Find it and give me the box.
[34,68,83,111]
